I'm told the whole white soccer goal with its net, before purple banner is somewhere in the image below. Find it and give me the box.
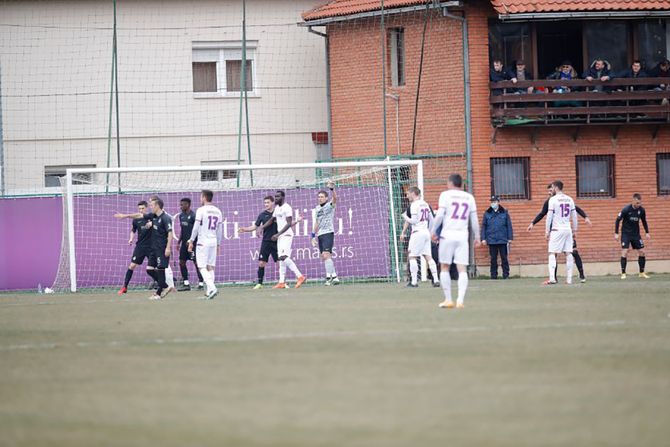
[53,160,423,292]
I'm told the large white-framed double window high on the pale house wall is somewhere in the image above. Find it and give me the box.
[192,41,257,97]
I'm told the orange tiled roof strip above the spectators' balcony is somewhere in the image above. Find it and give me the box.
[491,0,670,15]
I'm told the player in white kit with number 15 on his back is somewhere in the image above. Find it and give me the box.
[545,180,577,284]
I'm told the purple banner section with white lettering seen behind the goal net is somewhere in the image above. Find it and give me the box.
[70,187,391,288]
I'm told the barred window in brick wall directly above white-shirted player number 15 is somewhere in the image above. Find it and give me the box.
[576,155,614,198]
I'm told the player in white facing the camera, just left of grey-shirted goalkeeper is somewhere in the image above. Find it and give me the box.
[261,191,307,289]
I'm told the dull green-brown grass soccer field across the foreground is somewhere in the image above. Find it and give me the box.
[0,275,670,446]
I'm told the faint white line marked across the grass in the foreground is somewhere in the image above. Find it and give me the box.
[0,320,670,352]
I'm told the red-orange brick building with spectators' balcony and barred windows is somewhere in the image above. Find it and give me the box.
[303,0,670,275]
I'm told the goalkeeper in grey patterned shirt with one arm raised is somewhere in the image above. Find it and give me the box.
[312,182,340,286]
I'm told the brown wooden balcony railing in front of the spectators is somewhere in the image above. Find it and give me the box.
[490,78,670,127]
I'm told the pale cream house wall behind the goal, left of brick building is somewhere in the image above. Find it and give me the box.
[0,0,328,195]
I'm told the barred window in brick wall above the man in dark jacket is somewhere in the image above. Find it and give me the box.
[491,157,530,199]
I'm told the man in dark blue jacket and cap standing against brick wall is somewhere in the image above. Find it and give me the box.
[481,196,514,279]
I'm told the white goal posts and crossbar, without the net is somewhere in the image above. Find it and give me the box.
[64,157,423,292]
